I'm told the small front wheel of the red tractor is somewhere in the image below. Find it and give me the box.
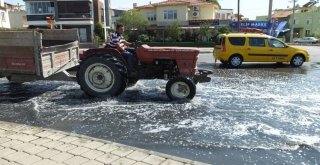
[166,77,196,100]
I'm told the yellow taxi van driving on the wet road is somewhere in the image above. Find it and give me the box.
[213,33,310,68]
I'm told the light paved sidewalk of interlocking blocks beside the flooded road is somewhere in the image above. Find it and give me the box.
[0,121,208,165]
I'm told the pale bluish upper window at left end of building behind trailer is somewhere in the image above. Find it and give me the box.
[26,2,54,14]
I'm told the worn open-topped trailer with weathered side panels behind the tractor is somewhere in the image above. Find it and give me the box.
[0,29,79,82]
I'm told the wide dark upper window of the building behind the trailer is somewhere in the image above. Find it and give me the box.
[58,1,91,18]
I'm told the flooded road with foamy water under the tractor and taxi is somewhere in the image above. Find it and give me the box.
[0,62,320,165]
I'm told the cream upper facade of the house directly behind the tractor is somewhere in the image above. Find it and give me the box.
[134,0,219,28]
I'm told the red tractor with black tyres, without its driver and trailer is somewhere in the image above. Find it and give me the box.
[77,45,212,100]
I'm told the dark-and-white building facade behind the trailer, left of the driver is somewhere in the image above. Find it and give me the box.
[24,0,105,42]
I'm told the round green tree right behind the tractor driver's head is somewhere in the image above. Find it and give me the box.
[117,11,148,41]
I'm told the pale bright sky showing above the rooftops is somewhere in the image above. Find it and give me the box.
[4,0,316,20]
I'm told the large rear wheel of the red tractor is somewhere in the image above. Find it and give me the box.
[78,56,127,97]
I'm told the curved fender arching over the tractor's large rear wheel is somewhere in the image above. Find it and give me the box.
[80,48,126,62]
